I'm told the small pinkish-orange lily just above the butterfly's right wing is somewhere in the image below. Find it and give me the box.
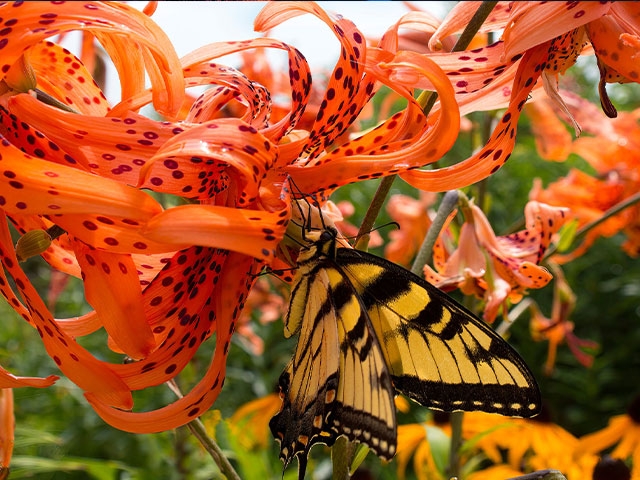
[424,202,568,322]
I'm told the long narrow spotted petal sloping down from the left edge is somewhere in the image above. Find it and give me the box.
[0,213,133,409]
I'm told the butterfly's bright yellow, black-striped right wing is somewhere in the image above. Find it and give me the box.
[336,249,540,417]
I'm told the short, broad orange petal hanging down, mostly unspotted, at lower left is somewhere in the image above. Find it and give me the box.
[74,241,156,359]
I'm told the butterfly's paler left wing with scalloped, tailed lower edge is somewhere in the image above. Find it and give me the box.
[270,246,397,478]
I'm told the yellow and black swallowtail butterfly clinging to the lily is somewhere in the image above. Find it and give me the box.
[269,222,541,479]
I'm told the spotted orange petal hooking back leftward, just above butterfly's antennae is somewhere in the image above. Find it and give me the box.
[287,48,460,193]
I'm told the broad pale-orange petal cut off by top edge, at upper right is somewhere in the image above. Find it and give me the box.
[502,2,612,58]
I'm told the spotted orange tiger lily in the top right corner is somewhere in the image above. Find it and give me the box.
[387,1,640,191]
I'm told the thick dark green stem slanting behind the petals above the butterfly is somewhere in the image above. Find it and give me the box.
[356,0,498,250]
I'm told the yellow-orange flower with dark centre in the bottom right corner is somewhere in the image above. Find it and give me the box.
[579,395,640,480]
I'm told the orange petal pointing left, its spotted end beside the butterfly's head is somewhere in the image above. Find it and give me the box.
[142,205,288,260]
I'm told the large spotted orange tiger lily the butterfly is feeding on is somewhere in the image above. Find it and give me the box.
[0,2,459,432]
